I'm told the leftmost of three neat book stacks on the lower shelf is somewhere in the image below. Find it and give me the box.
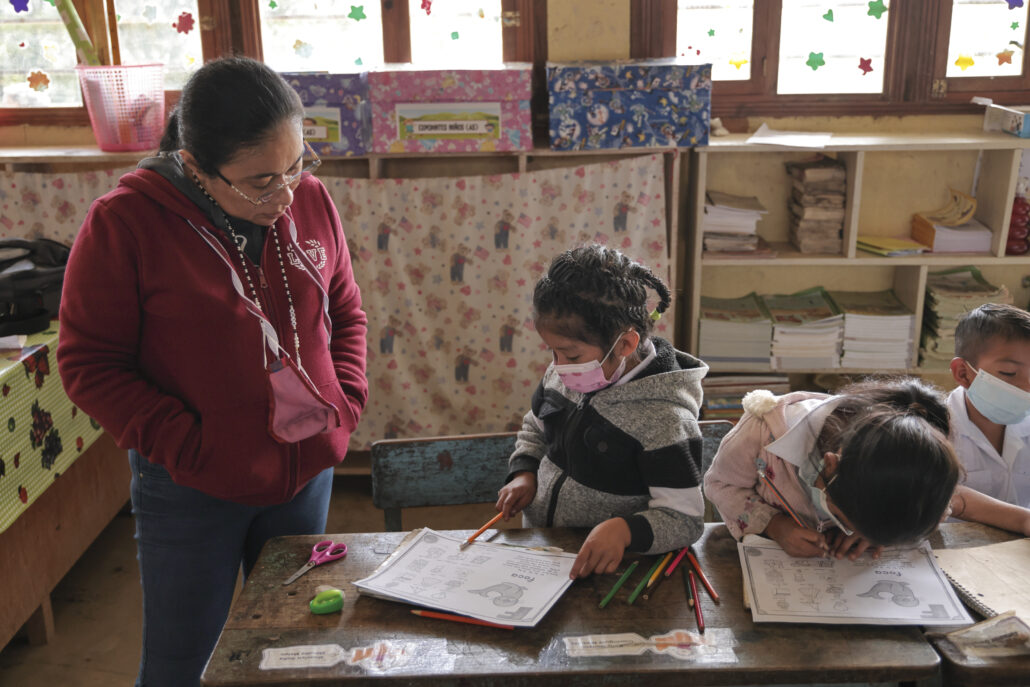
[697,293,773,370]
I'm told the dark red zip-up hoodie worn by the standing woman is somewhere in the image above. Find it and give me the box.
[58,169,368,506]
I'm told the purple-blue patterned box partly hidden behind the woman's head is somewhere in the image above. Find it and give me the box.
[282,72,372,157]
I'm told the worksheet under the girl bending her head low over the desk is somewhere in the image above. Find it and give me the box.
[736,535,971,625]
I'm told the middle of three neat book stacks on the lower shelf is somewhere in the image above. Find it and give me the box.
[762,286,844,370]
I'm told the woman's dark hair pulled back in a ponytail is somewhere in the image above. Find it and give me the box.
[161,58,304,176]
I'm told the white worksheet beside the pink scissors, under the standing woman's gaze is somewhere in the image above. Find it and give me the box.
[354,528,576,627]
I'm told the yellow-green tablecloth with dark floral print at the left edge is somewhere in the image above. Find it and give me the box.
[0,320,103,531]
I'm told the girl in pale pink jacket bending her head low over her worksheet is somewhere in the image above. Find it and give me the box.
[705,378,961,559]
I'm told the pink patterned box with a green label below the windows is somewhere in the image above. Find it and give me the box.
[369,63,533,152]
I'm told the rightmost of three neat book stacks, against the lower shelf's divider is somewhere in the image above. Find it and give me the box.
[829,289,916,370]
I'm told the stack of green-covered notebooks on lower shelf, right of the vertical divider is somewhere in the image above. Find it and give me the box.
[920,266,1012,366]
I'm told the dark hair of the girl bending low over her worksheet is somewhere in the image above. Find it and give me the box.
[817,377,962,546]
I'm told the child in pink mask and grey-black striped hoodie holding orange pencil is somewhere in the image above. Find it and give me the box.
[496,245,708,578]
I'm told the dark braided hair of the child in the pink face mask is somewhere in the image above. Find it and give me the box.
[533,244,672,348]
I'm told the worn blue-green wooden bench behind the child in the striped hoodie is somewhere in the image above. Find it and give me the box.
[372,420,733,531]
